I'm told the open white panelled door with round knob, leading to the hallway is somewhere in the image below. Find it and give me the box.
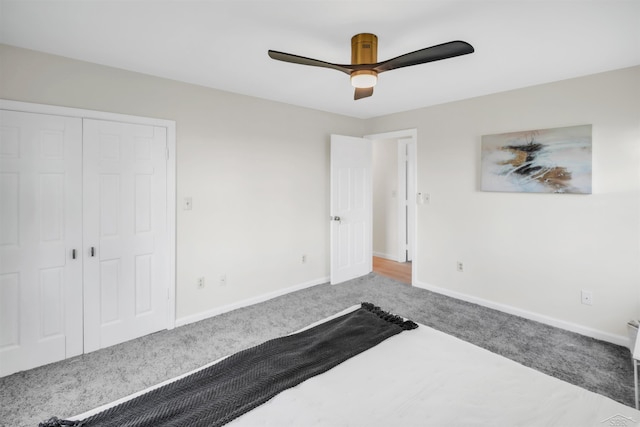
[331,135,373,284]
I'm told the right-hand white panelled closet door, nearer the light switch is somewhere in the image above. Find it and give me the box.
[83,119,170,352]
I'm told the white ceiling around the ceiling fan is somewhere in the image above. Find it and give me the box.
[0,0,640,118]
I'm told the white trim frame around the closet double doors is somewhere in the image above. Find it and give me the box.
[0,99,177,329]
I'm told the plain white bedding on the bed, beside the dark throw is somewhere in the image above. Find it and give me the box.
[74,308,640,427]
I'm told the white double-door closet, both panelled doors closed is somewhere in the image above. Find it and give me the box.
[0,104,175,376]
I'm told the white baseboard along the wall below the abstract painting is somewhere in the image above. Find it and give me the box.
[413,280,629,347]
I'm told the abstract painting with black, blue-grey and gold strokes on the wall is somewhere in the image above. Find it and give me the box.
[481,125,591,194]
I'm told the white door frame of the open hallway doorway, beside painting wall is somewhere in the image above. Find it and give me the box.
[364,128,418,284]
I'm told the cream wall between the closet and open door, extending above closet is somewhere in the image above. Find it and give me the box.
[0,45,364,323]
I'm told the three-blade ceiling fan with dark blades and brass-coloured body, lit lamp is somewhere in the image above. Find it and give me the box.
[269,33,474,100]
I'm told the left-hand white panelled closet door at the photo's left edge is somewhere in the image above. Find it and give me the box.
[0,110,82,376]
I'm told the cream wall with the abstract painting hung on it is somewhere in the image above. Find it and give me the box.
[367,67,640,341]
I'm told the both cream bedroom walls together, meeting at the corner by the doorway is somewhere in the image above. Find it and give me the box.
[0,46,640,342]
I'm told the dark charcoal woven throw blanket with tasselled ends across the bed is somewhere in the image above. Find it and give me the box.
[40,303,418,427]
